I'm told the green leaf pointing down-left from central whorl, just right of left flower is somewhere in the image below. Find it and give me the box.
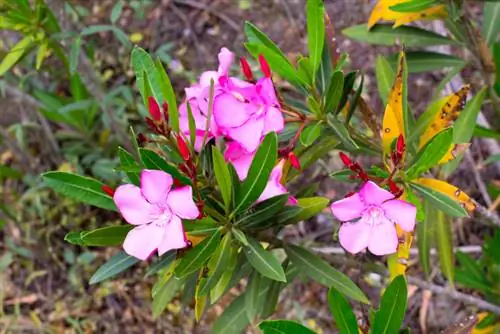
[175,228,222,277]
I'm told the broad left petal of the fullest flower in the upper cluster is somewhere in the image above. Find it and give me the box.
[213,93,252,128]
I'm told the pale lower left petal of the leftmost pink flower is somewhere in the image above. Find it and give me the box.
[123,223,164,260]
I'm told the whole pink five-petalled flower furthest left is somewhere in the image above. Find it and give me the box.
[113,169,199,260]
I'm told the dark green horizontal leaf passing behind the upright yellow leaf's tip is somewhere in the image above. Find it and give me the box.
[388,51,466,73]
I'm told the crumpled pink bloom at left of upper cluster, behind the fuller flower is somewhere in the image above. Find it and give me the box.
[179,48,251,152]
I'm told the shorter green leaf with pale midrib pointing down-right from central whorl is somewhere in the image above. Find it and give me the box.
[243,236,286,282]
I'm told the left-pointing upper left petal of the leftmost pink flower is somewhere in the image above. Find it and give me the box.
[113,184,153,225]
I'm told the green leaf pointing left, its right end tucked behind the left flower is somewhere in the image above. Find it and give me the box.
[64,225,134,246]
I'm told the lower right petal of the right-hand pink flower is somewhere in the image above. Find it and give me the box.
[368,220,399,256]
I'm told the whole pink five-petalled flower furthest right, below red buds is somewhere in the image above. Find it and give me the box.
[330,181,417,255]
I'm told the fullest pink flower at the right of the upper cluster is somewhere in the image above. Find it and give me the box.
[214,77,284,152]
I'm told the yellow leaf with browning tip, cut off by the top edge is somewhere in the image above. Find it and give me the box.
[368,0,448,29]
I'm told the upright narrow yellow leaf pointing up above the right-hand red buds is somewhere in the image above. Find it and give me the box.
[382,52,405,153]
